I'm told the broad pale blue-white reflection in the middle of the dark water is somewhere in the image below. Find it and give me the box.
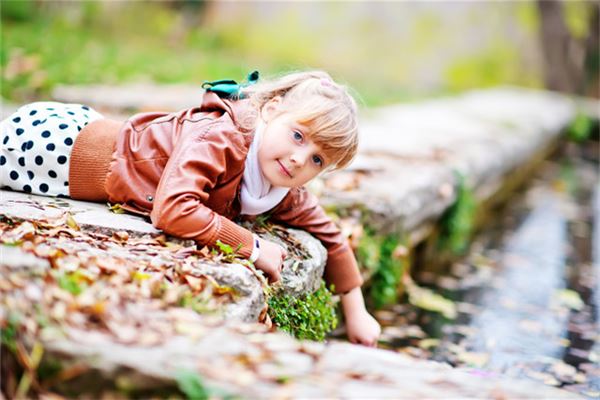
[469,191,566,370]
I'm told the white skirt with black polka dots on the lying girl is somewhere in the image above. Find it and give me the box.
[0,102,102,196]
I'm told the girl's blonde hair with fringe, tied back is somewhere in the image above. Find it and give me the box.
[243,71,358,169]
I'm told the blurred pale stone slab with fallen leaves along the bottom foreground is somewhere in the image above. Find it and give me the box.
[27,324,579,399]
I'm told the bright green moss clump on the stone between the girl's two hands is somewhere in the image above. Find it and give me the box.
[268,282,338,341]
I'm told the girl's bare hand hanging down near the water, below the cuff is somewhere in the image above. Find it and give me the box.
[342,287,381,347]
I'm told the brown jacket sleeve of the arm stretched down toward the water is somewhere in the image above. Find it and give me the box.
[271,188,363,293]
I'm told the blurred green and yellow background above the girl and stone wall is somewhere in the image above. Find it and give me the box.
[0,0,598,106]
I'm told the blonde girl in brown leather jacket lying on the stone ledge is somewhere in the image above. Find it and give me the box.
[0,71,380,346]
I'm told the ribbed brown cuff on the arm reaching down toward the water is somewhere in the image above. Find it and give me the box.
[324,243,363,294]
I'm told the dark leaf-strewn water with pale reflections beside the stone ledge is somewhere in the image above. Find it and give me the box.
[376,142,600,398]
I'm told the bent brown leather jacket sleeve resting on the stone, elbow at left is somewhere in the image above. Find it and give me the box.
[150,122,253,258]
